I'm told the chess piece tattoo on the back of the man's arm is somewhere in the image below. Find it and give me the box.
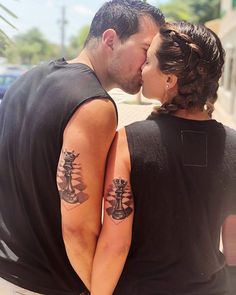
[57,150,88,205]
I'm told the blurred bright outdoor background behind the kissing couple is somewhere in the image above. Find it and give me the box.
[0,0,236,128]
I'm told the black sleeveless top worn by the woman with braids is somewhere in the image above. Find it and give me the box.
[114,115,236,295]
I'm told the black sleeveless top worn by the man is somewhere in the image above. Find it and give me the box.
[0,59,115,295]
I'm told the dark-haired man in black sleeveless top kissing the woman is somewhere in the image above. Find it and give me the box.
[0,0,164,295]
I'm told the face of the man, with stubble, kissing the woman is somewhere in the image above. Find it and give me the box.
[108,17,159,94]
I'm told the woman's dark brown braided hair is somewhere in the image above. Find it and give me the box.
[153,22,225,116]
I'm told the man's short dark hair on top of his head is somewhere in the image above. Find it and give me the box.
[85,0,165,46]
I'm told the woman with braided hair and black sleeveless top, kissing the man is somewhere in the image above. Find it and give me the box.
[92,22,236,295]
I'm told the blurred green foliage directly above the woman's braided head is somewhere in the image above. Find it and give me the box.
[159,0,220,23]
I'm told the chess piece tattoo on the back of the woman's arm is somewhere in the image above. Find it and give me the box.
[105,178,133,223]
